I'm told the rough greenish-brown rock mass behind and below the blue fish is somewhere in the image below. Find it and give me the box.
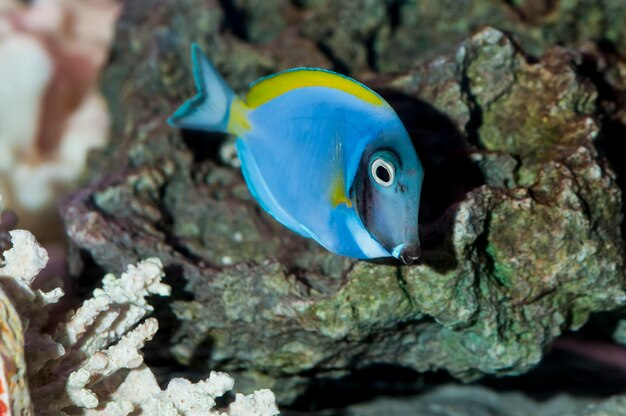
[62,0,626,401]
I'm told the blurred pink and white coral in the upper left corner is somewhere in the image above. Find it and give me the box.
[0,0,121,236]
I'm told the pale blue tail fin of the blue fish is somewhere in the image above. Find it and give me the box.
[167,43,236,133]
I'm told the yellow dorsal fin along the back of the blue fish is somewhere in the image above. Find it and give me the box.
[246,68,385,108]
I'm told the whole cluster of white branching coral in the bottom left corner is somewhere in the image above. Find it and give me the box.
[0,230,279,416]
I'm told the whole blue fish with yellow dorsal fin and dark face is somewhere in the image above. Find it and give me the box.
[168,44,424,264]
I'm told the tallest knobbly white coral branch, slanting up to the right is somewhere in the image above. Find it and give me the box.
[32,258,170,414]
